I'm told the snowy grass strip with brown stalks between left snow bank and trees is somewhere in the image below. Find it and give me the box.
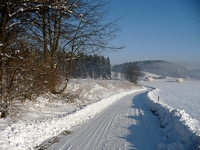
[0,79,139,126]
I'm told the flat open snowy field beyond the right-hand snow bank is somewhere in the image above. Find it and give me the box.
[141,78,200,121]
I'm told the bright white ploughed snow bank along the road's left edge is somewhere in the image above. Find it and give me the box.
[0,89,141,150]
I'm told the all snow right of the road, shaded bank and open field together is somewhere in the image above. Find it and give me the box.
[141,74,200,149]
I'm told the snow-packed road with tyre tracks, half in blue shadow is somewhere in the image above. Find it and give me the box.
[49,91,166,150]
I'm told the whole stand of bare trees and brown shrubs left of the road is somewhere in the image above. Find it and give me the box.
[0,0,122,118]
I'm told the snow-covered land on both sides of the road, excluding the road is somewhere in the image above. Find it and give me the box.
[0,78,200,150]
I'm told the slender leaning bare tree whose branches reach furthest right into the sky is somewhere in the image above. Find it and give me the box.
[58,0,123,91]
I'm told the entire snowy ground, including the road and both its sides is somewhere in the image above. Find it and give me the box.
[0,79,200,150]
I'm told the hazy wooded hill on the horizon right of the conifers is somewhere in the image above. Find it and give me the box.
[112,60,187,78]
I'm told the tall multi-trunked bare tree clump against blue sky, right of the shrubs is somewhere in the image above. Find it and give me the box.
[21,0,122,93]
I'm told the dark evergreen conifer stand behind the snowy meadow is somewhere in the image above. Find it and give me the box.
[71,55,111,79]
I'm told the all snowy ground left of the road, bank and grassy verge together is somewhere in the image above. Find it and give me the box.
[0,80,141,150]
